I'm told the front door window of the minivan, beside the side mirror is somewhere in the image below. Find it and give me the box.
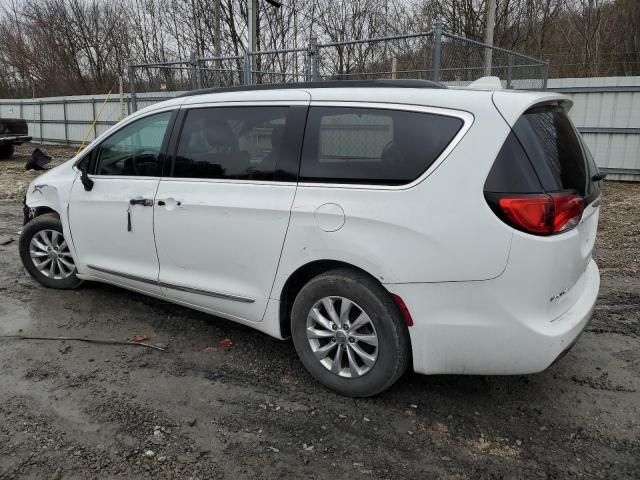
[90,112,172,177]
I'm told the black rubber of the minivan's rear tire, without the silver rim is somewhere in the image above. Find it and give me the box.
[291,268,411,397]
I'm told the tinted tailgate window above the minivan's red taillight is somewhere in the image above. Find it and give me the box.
[513,105,587,196]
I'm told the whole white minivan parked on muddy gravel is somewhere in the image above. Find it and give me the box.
[20,80,603,396]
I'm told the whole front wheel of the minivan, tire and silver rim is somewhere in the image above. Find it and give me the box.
[19,213,82,290]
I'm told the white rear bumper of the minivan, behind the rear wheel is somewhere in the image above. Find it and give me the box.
[386,260,600,375]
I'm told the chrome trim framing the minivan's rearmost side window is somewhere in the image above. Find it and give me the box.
[298,100,475,191]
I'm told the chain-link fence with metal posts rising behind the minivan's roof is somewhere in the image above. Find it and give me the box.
[129,22,549,110]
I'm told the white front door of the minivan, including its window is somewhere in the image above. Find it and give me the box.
[69,112,172,294]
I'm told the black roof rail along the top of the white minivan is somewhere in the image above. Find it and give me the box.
[179,79,447,97]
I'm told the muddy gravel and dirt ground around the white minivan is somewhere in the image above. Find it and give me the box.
[0,146,640,480]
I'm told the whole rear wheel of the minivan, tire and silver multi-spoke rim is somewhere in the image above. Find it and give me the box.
[291,269,411,397]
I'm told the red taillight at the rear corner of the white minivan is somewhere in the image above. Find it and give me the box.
[488,193,584,235]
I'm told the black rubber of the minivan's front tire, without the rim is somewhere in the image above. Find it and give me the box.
[19,213,82,290]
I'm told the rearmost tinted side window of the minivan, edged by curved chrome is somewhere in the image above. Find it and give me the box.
[300,107,463,185]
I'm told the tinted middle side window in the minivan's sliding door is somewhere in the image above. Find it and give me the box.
[172,106,292,180]
